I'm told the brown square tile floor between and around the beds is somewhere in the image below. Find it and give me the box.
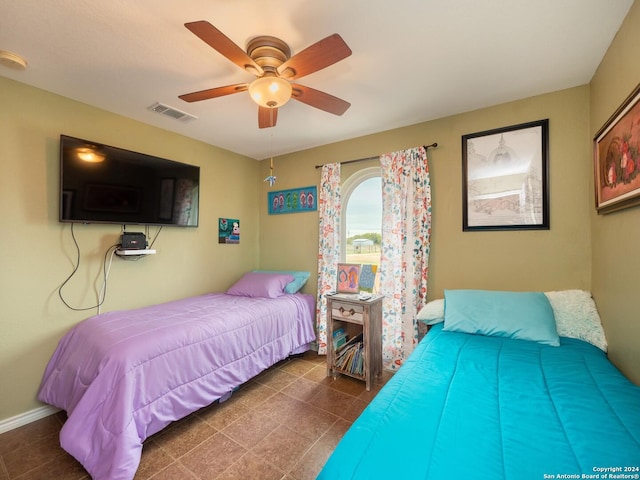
[0,352,391,480]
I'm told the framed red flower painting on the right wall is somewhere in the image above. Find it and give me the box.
[593,84,640,214]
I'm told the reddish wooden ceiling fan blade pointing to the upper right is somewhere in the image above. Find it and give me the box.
[278,33,351,79]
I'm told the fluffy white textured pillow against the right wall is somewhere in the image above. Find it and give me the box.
[545,290,607,352]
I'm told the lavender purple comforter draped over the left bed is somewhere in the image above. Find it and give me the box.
[38,293,315,480]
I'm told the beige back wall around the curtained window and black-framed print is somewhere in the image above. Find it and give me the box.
[259,86,592,299]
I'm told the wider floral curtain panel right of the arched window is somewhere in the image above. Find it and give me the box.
[380,147,431,370]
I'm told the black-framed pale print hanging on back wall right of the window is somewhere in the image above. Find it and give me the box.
[462,119,549,231]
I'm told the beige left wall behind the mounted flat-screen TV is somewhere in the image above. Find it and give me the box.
[0,77,259,421]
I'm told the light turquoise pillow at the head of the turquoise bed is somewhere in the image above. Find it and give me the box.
[443,290,560,347]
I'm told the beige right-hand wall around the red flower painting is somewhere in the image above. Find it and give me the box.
[589,2,640,384]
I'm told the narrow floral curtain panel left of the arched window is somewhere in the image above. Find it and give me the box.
[316,163,342,354]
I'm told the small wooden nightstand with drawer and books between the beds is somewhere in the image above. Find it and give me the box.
[327,294,383,390]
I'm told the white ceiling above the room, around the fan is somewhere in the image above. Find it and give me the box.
[0,0,633,159]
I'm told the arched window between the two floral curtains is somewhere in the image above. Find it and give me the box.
[341,167,382,265]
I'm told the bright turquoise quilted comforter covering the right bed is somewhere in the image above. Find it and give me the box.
[318,324,640,480]
